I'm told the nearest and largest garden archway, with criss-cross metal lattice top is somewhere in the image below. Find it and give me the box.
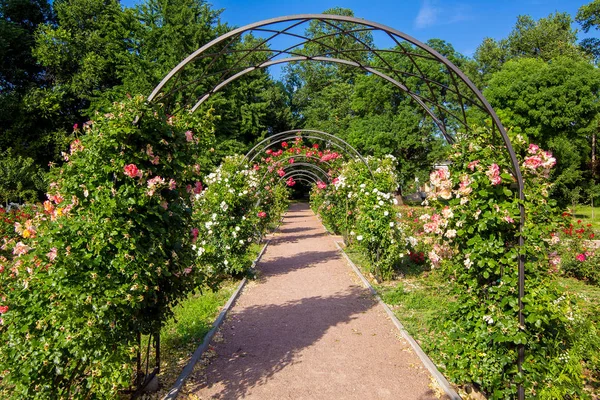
[148,14,525,398]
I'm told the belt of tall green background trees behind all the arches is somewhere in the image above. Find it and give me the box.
[0,0,600,205]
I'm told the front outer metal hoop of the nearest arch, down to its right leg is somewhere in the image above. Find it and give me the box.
[148,14,525,399]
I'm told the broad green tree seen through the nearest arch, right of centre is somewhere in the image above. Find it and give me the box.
[285,21,452,186]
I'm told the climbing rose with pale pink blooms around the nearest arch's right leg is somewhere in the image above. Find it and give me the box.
[430,132,597,399]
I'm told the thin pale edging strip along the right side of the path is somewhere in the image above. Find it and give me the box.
[334,240,462,400]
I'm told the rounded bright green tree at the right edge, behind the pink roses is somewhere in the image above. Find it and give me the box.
[484,57,600,203]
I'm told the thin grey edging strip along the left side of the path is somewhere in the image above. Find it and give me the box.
[162,239,271,400]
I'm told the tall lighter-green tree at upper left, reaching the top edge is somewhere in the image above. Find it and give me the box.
[34,0,137,114]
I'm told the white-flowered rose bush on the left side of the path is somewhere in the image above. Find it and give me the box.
[192,156,288,286]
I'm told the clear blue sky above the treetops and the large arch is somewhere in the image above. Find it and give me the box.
[122,0,591,56]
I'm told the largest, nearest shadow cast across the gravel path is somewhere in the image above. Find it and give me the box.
[188,287,376,399]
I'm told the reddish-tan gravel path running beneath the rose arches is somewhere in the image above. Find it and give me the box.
[181,203,440,400]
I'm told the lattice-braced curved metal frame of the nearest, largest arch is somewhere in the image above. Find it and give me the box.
[148,14,525,399]
